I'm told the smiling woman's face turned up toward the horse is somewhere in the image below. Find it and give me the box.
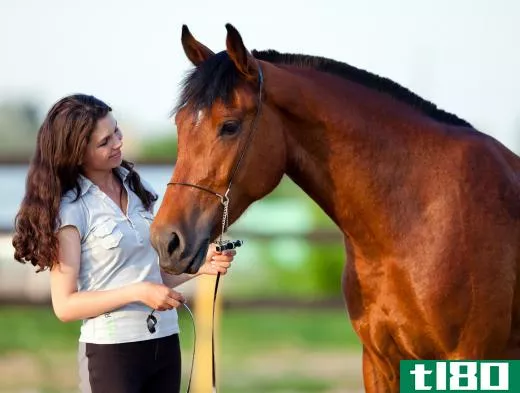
[82,112,123,172]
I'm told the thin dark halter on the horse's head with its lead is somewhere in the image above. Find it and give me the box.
[166,63,264,393]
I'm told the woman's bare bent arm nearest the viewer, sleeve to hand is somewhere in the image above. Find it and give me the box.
[50,226,184,322]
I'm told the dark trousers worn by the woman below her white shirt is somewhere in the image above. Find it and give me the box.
[86,334,181,393]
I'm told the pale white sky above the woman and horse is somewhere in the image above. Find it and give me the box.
[0,0,520,152]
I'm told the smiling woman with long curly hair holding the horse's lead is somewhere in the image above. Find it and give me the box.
[13,94,234,393]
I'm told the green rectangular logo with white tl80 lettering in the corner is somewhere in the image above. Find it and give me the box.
[400,360,520,393]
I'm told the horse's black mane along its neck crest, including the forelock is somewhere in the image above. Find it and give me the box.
[175,50,473,128]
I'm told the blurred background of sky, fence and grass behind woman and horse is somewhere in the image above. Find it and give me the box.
[0,0,520,393]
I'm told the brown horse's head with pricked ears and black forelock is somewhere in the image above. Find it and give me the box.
[151,24,286,273]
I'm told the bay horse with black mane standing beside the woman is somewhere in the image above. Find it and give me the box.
[152,24,520,392]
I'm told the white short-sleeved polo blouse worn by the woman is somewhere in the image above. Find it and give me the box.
[58,167,179,344]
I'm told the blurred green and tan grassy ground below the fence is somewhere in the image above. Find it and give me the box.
[0,306,361,393]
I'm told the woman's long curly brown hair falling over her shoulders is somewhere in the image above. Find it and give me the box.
[13,94,157,271]
